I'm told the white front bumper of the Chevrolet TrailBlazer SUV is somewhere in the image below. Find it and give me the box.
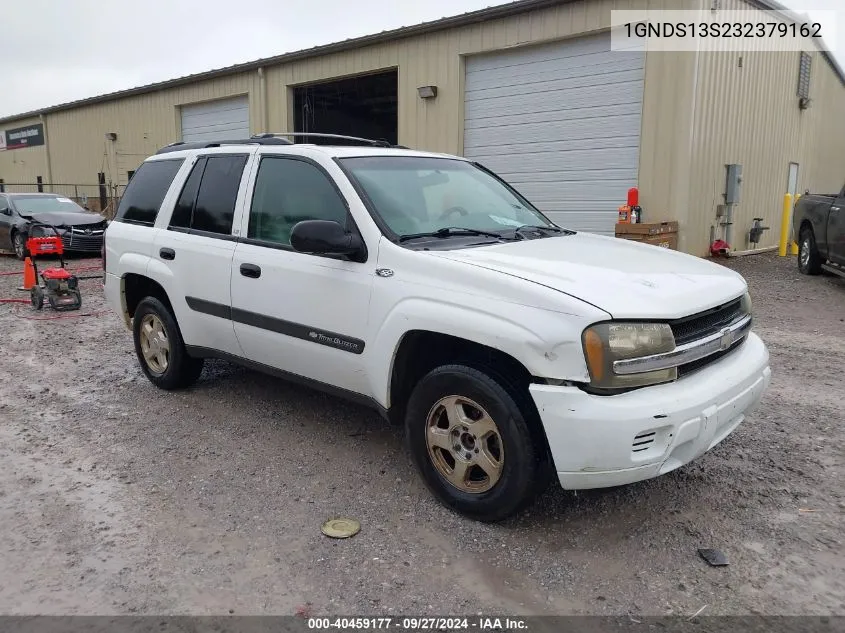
[530,332,771,490]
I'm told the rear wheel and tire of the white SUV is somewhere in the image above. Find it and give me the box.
[132,297,203,390]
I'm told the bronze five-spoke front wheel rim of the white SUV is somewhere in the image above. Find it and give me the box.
[425,396,505,494]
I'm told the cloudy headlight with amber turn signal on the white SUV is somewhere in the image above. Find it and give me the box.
[583,323,678,389]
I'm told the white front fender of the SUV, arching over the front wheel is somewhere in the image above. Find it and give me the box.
[368,297,590,407]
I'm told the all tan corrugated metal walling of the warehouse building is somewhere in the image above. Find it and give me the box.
[0,0,845,254]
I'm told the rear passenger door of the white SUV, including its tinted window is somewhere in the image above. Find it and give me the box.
[151,149,251,356]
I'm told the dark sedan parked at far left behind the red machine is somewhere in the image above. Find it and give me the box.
[0,193,107,259]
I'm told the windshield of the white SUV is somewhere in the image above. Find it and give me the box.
[340,156,554,238]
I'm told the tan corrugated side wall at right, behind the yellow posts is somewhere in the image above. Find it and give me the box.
[680,0,845,255]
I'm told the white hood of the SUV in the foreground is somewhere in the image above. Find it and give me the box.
[428,233,747,319]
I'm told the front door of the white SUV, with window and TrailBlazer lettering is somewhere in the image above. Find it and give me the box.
[232,155,373,395]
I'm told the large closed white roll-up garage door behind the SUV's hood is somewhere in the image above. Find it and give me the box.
[464,33,645,235]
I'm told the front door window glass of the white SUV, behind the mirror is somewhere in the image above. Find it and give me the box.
[247,157,348,244]
